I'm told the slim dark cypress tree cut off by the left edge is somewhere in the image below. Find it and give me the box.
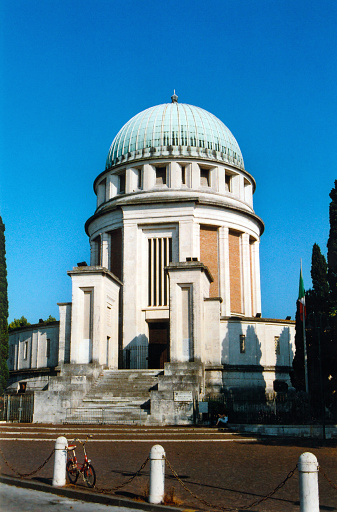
[0,216,9,394]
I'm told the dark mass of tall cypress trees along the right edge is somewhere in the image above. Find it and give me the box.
[292,180,337,416]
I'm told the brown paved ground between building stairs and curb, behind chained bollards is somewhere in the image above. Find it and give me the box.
[0,424,337,512]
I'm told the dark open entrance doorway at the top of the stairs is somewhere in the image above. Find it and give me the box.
[148,322,169,369]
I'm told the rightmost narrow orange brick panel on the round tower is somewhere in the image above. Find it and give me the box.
[228,231,243,313]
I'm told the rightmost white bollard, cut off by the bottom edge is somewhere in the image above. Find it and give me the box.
[298,452,319,512]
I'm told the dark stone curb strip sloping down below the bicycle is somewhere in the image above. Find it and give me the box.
[0,475,196,512]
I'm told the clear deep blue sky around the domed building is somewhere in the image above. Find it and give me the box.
[0,0,337,323]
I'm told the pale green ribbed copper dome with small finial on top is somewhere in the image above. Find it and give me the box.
[106,99,244,169]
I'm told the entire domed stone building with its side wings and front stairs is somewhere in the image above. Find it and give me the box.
[8,94,294,424]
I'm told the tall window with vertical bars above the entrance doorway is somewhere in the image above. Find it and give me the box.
[148,237,172,306]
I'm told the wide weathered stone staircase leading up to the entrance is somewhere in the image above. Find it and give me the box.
[66,370,163,425]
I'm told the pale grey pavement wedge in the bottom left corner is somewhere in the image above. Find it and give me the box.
[0,476,185,512]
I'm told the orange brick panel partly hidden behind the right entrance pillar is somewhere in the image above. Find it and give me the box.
[200,226,219,297]
